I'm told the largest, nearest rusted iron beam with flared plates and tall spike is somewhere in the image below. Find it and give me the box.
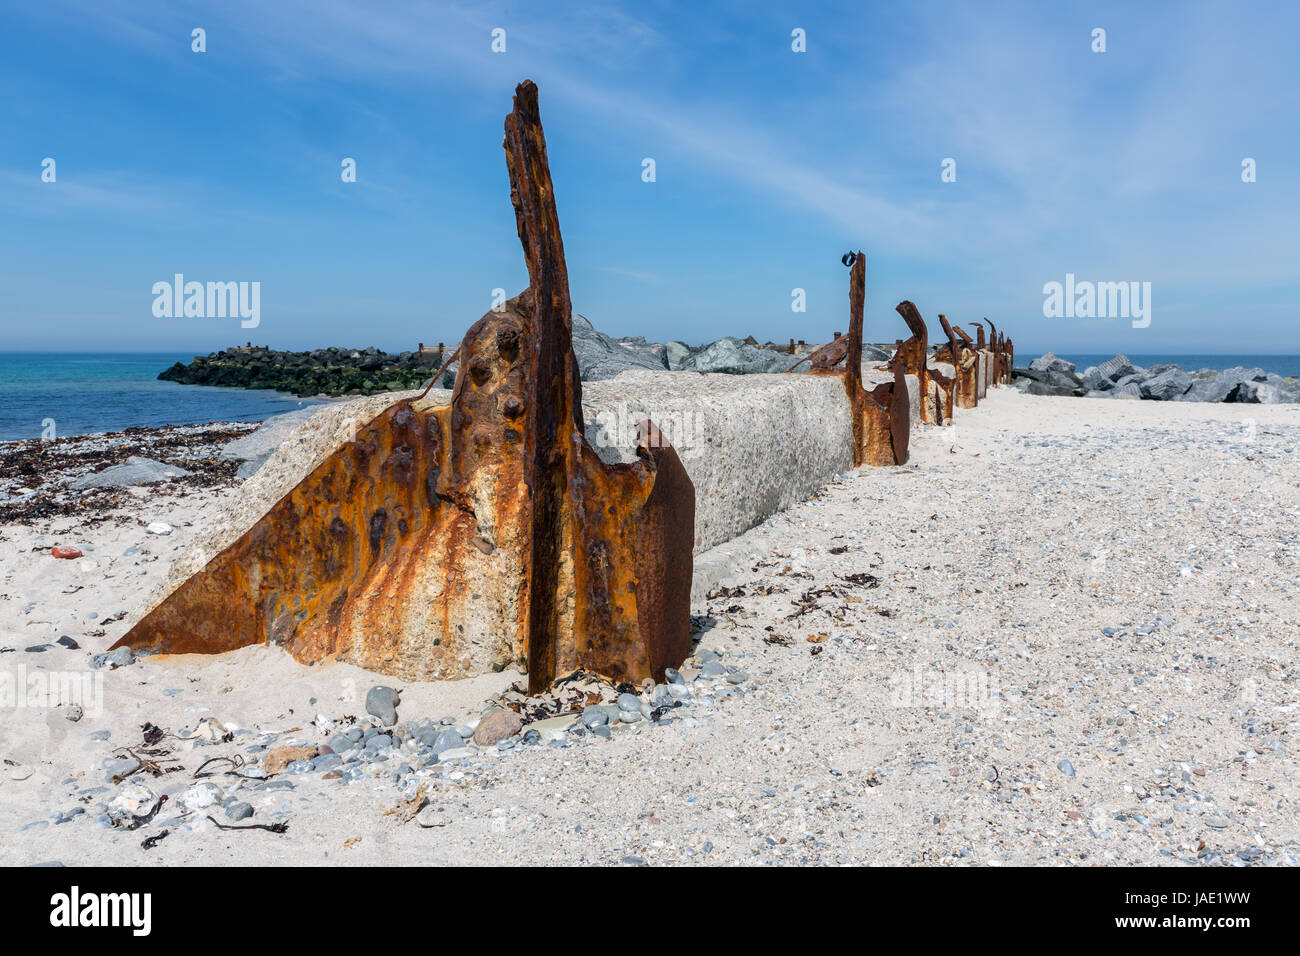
[114,82,694,692]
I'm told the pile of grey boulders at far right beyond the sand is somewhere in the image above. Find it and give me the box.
[1014,352,1300,405]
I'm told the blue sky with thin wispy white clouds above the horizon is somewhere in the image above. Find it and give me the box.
[0,0,1300,355]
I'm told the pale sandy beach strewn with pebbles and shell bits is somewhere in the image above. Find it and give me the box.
[0,389,1300,866]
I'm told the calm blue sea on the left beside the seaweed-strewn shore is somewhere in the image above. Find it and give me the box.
[0,352,332,441]
